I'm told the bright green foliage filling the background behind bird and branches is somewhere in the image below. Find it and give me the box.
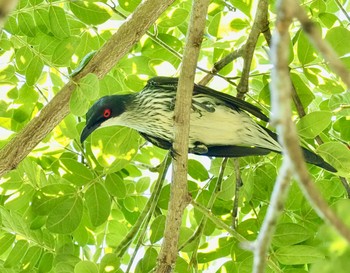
[0,0,350,273]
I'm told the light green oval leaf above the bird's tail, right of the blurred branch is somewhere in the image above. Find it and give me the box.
[297,111,332,138]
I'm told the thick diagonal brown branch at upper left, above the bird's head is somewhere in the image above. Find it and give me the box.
[0,0,173,176]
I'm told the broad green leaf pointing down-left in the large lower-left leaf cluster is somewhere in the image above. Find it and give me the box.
[46,196,83,234]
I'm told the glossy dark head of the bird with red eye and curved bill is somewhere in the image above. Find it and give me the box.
[80,95,129,143]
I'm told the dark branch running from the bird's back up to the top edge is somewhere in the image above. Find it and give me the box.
[237,0,269,98]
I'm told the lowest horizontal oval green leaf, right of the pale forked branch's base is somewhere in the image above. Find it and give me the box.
[275,245,325,265]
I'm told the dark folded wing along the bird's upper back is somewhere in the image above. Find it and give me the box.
[147,77,269,122]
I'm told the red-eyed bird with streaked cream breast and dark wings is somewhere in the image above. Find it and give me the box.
[80,76,337,172]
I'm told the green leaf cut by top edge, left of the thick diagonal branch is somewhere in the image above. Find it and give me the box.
[69,1,110,25]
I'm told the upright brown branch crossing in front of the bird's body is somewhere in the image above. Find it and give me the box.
[156,0,210,273]
